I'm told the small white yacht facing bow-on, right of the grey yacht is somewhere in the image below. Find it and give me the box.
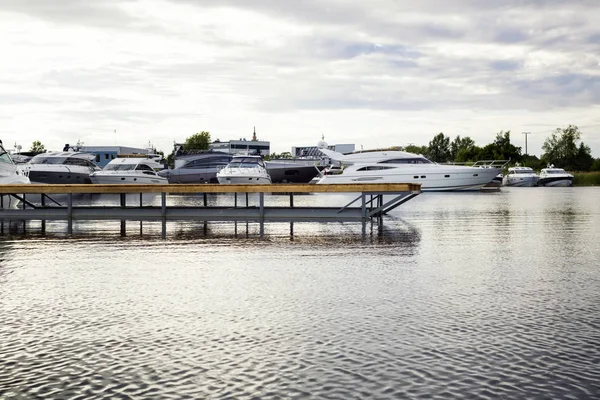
[217,156,271,184]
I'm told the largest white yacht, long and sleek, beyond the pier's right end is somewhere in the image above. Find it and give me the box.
[317,148,502,191]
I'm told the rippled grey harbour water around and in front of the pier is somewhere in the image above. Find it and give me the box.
[0,188,600,399]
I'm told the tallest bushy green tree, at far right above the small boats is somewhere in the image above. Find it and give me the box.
[542,125,594,171]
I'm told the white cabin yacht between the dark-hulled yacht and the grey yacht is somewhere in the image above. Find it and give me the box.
[90,157,169,184]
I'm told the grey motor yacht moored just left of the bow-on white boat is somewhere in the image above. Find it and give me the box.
[158,151,233,183]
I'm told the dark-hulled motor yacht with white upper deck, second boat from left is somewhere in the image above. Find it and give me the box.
[27,151,100,184]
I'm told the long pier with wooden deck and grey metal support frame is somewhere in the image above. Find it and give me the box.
[0,183,421,233]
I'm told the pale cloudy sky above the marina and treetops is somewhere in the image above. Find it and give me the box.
[0,0,600,157]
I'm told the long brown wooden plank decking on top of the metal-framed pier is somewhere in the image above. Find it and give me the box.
[0,183,421,194]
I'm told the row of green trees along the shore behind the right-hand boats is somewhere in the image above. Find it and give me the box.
[403,125,600,171]
